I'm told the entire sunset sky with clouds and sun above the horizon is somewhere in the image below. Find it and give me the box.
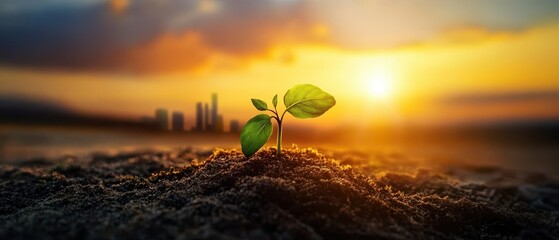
[0,0,559,129]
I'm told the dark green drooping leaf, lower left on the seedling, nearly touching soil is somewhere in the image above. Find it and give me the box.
[241,114,272,157]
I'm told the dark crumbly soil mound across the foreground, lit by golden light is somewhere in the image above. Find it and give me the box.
[0,148,559,239]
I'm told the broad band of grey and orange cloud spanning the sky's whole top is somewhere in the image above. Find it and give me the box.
[0,0,559,73]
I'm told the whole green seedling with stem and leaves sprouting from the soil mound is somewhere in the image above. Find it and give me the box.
[241,84,336,158]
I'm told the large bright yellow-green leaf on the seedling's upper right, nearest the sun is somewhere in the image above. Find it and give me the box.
[283,84,336,118]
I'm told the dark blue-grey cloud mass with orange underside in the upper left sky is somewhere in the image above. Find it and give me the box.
[0,0,318,73]
